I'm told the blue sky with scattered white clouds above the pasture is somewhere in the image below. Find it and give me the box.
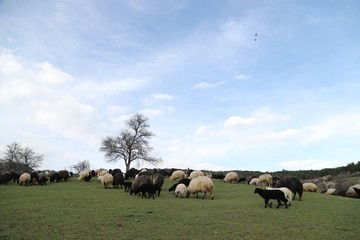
[0,0,360,172]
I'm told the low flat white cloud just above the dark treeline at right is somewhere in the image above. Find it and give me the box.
[278,159,340,170]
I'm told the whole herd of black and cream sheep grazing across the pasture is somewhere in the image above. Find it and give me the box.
[0,169,360,208]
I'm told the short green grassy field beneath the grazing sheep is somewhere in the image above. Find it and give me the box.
[0,178,360,240]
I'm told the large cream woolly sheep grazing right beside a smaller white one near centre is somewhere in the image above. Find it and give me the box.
[186,176,214,200]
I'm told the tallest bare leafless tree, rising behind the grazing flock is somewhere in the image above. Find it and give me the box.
[100,114,162,171]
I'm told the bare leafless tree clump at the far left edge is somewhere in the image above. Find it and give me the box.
[0,142,44,172]
